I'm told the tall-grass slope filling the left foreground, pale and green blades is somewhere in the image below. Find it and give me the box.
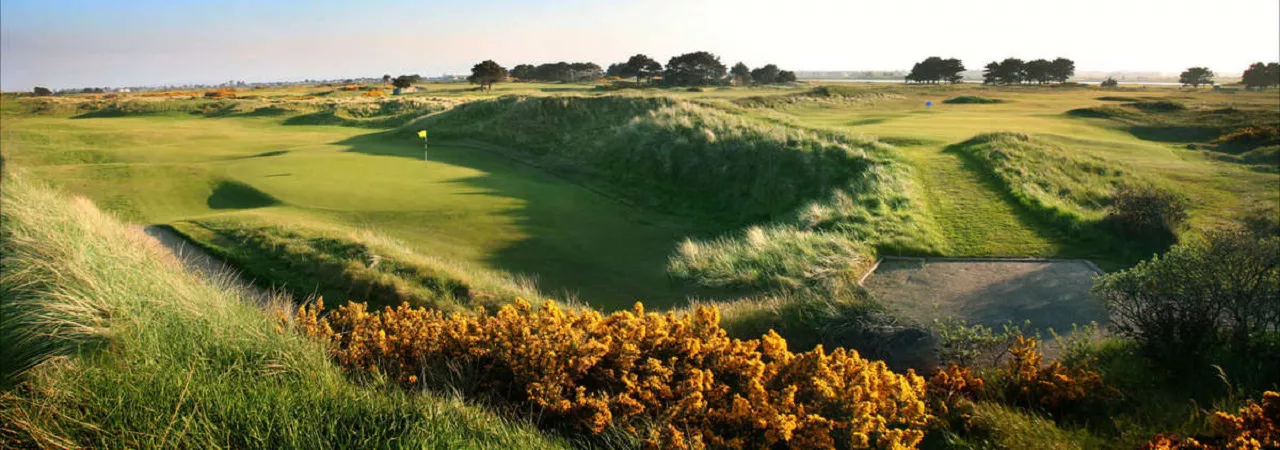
[0,176,563,449]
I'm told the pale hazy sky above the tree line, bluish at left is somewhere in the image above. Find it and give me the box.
[0,0,1280,91]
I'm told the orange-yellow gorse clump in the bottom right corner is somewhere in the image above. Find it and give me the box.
[1142,391,1280,450]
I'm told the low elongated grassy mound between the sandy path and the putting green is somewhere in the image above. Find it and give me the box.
[172,216,541,311]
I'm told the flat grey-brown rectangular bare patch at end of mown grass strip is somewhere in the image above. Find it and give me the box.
[863,258,1107,331]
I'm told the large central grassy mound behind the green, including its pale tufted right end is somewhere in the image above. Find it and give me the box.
[406,97,937,288]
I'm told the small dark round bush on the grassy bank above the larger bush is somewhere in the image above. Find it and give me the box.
[1106,185,1187,242]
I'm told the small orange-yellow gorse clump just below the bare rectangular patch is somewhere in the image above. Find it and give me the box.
[1001,336,1117,415]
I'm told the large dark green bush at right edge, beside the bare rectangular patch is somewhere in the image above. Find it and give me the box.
[1093,229,1280,363]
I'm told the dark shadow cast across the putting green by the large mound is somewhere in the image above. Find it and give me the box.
[338,132,744,311]
